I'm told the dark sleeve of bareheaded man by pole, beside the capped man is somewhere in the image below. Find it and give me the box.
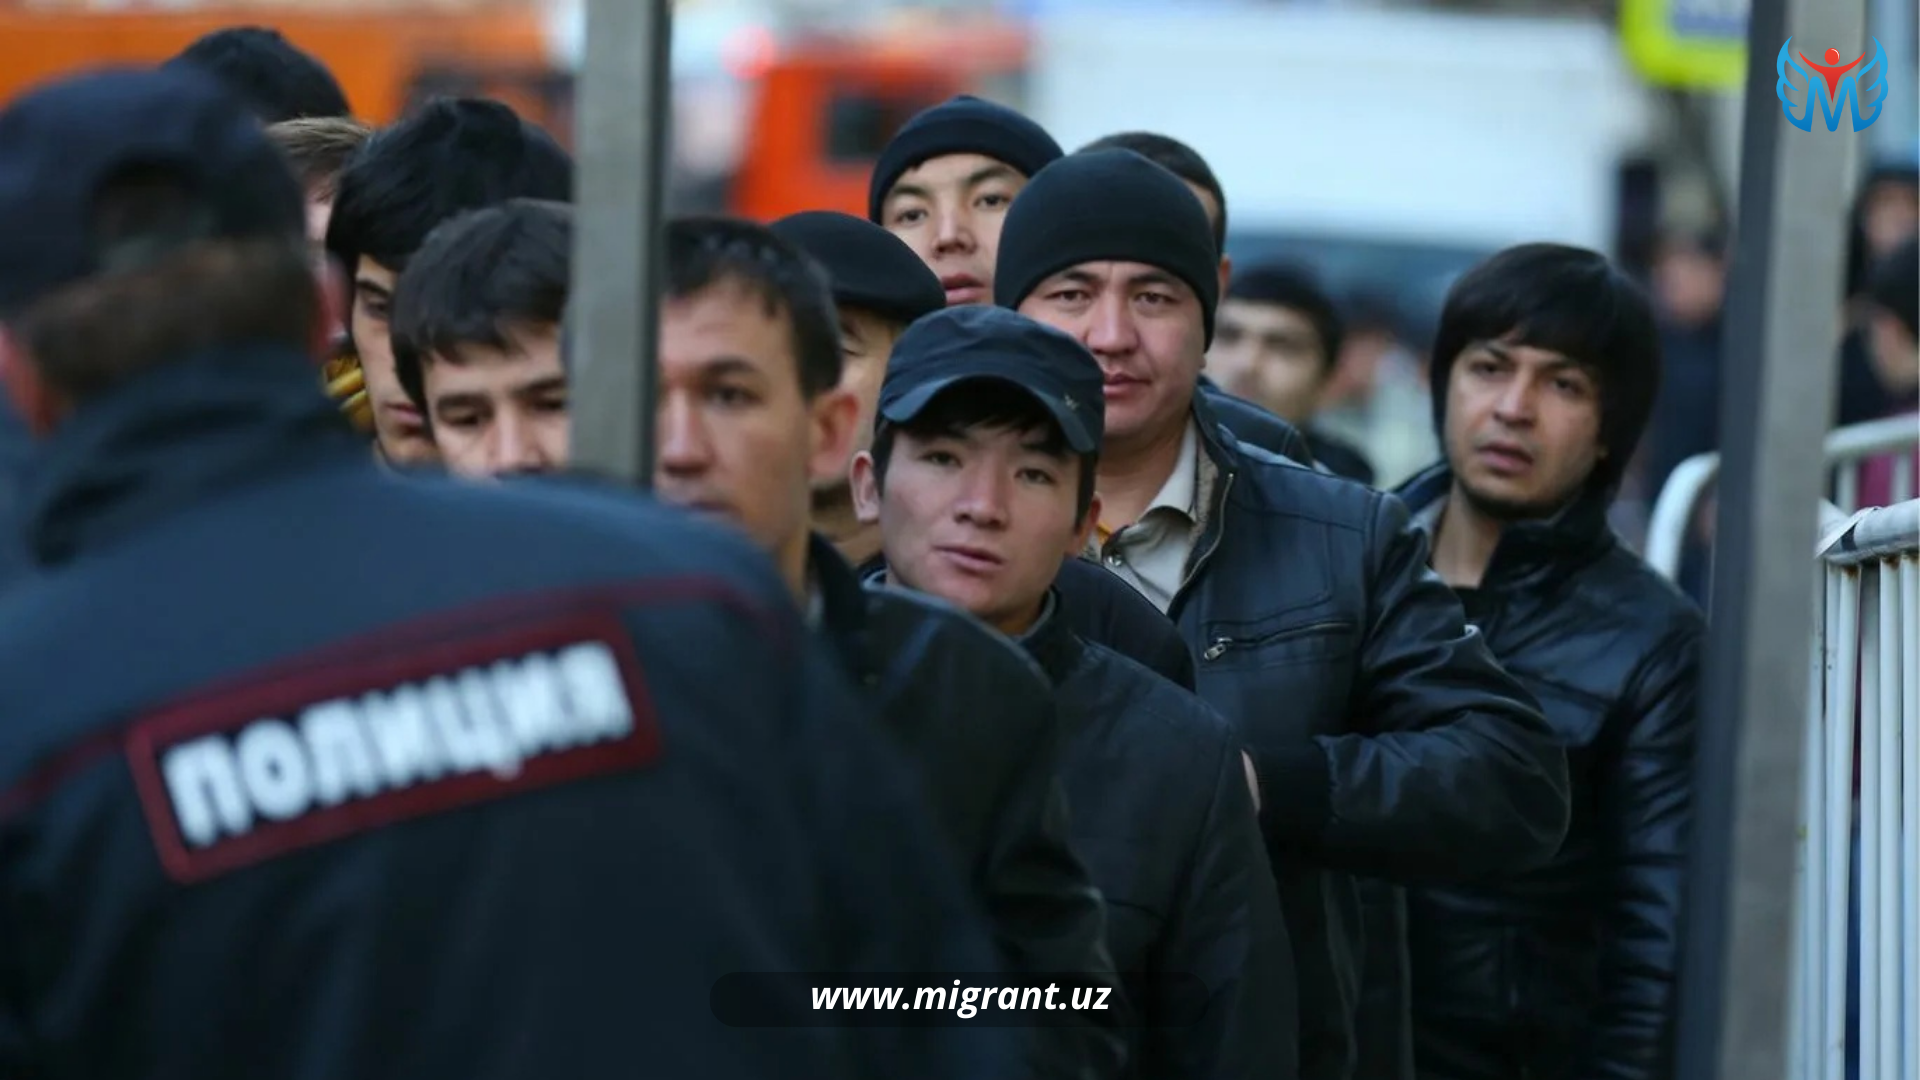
[983,675,1125,1078]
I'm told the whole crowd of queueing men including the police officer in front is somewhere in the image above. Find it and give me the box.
[0,21,1904,1080]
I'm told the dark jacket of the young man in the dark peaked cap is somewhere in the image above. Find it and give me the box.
[1021,591,1300,1080]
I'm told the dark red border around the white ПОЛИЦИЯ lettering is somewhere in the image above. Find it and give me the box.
[125,607,660,884]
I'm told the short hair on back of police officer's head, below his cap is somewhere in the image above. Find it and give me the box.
[8,167,321,402]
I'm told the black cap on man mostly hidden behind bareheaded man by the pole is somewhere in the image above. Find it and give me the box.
[768,209,947,323]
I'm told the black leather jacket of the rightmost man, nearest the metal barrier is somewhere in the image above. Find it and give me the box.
[1402,467,1705,1080]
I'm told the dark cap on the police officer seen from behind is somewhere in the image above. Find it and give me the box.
[0,69,307,319]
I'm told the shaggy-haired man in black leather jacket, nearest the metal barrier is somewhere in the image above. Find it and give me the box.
[1402,244,1705,1080]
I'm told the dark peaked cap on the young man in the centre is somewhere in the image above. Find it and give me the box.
[879,304,1106,454]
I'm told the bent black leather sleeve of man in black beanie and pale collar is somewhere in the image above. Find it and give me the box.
[1256,488,1571,884]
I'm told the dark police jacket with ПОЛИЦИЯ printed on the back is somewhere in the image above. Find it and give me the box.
[0,350,1014,1080]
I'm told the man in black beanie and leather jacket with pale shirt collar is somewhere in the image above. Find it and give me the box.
[995,150,1569,1080]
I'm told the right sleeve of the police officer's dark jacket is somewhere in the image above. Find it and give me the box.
[793,644,1027,1080]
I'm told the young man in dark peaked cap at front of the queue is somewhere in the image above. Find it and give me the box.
[854,307,1298,1078]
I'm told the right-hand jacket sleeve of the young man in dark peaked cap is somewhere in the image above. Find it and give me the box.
[1133,734,1300,1080]
